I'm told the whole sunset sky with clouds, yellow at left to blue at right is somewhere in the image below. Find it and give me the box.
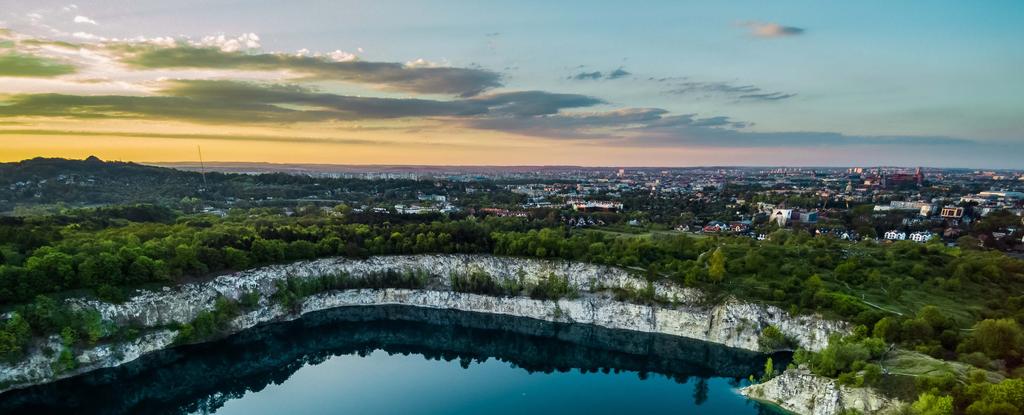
[0,0,1024,168]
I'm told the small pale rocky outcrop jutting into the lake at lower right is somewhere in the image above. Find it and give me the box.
[739,369,903,415]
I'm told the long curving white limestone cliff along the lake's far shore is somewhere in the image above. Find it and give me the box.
[0,255,848,390]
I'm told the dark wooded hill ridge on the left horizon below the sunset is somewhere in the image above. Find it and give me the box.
[0,158,523,211]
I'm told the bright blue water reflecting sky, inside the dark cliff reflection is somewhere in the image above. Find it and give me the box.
[217,350,759,415]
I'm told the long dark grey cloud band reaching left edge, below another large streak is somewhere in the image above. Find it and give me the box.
[0,80,603,123]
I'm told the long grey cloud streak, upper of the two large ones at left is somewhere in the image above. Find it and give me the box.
[123,45,501,96]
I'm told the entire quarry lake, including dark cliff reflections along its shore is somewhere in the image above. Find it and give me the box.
[0,305,785,415]
